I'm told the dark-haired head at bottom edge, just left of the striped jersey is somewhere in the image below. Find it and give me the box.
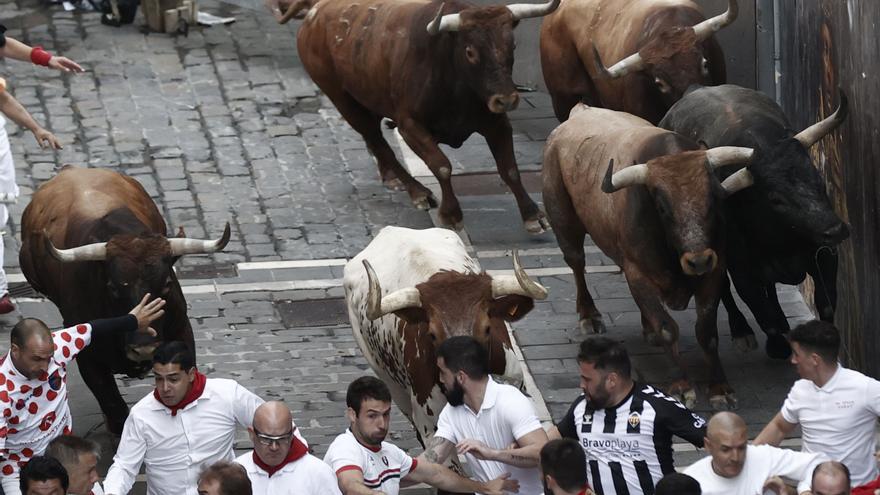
[541,438,593,495]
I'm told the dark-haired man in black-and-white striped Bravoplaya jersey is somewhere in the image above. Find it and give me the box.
[550,337,706,495]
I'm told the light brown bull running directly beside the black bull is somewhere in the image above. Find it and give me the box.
[544,105,752,408]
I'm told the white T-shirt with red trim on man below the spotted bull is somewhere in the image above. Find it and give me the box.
[324,430,418,495]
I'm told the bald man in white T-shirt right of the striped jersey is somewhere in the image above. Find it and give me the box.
[684,412,828,495]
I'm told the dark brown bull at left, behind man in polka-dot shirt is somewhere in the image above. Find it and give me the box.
[19,167,229,433]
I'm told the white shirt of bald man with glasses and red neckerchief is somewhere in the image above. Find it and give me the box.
[235,451,340,495]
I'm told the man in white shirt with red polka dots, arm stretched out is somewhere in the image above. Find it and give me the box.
[0,294,165,495]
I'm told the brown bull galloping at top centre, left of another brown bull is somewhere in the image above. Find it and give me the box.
[287,0,559,233]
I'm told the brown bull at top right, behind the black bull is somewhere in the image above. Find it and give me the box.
[541,0,738,124]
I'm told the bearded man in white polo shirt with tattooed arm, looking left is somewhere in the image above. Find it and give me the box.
[419,336,547,495]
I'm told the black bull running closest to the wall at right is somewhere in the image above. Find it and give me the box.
[660,85,849,358]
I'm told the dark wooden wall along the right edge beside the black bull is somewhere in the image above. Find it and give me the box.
[778,0,880,376]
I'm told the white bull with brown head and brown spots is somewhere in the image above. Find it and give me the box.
[344,227,547,444]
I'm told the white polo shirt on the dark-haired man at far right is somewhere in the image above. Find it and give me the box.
[782,366,880,486]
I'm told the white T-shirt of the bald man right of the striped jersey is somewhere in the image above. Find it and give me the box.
[684,445,828,495]
